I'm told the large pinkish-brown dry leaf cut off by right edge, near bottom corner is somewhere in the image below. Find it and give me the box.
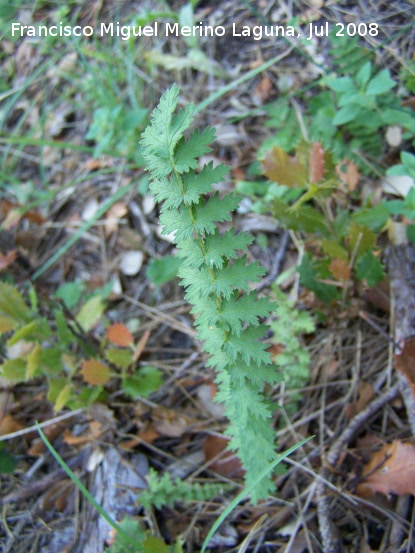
[356,440,415,497]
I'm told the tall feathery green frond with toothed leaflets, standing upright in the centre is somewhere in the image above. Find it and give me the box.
[141,85,282,502]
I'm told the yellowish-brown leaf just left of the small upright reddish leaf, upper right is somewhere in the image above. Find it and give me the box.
[262,146,308,187]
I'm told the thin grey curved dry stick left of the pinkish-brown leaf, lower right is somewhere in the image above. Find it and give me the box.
[317,383,400,553]
